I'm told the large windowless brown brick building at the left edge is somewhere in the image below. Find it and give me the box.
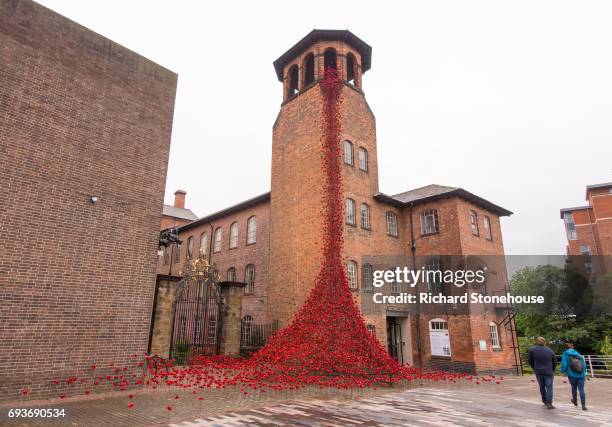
[0,0,177,400]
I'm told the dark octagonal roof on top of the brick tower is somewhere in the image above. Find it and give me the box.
[273,29,372,82]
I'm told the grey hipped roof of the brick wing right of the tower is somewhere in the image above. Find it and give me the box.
[374,184,512,216]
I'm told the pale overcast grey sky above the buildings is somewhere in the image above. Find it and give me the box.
[41,0,612,254]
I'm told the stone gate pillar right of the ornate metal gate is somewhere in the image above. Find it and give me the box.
[219,282,246,356]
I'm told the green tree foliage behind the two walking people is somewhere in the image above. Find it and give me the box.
[510,265,612,354]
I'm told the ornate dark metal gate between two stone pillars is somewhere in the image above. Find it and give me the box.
[170,257,223,365]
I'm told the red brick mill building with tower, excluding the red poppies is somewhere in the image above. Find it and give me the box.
[158,30,517,371]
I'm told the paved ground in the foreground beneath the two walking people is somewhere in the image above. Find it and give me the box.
[0,377,612,427]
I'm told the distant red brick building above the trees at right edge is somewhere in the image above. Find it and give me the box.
[561,182,612,273]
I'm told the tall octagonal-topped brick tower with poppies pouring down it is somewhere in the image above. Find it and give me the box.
[268,30,378,324]
